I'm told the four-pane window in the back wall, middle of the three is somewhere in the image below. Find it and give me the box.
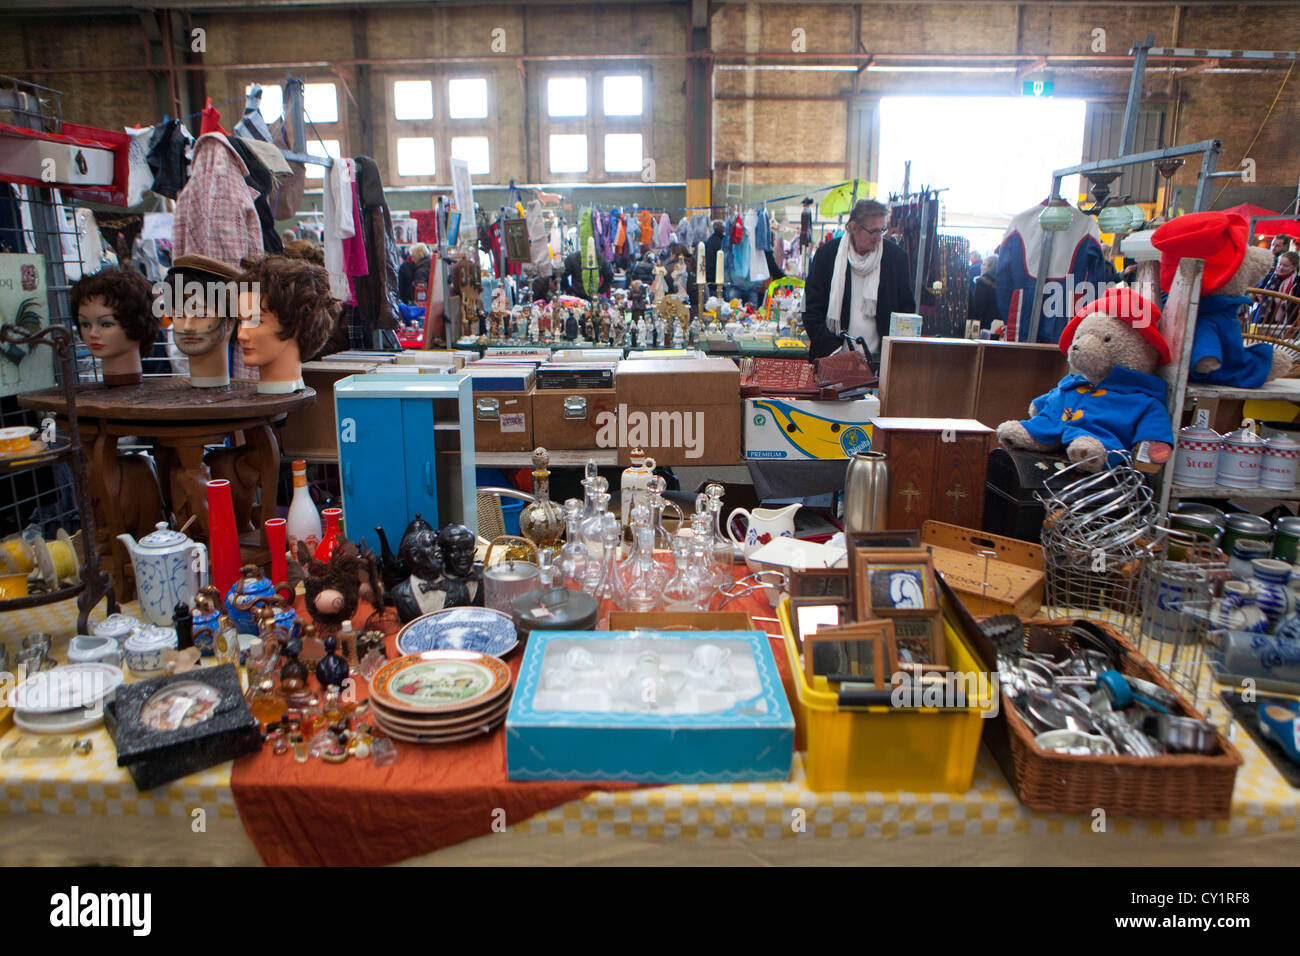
[387,77,497,185]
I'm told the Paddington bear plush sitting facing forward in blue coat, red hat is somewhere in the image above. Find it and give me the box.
[997,289,1174,471]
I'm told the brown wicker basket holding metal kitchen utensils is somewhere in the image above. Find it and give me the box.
[984,619,1242,819]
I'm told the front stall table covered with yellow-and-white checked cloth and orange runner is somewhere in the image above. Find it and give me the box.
[0,598,1300,865]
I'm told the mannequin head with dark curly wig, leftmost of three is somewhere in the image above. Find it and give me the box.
[72,269,159,385]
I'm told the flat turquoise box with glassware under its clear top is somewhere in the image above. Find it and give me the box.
[506,631,794,783]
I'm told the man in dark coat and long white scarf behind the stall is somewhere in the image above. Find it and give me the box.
[803,199,917,364]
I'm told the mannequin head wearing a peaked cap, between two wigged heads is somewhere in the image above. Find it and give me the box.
[165,255,239,388]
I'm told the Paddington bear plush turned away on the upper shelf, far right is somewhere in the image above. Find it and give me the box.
[1151,212,1291,389]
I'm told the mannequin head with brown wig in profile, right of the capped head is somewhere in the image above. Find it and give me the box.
[238,256,339,394]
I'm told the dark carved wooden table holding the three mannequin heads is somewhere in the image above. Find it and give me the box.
[18,378,316,598]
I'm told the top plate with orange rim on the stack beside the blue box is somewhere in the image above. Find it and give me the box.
[371,650,510,714]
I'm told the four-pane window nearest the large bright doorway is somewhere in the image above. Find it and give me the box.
[538,68,654,182]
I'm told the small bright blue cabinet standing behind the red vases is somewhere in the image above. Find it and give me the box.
[334,373,478,548]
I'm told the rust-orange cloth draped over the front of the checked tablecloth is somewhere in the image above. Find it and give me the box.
[230,566,789,866]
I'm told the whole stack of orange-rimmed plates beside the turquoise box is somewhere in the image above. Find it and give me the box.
[371,650,511,744]
